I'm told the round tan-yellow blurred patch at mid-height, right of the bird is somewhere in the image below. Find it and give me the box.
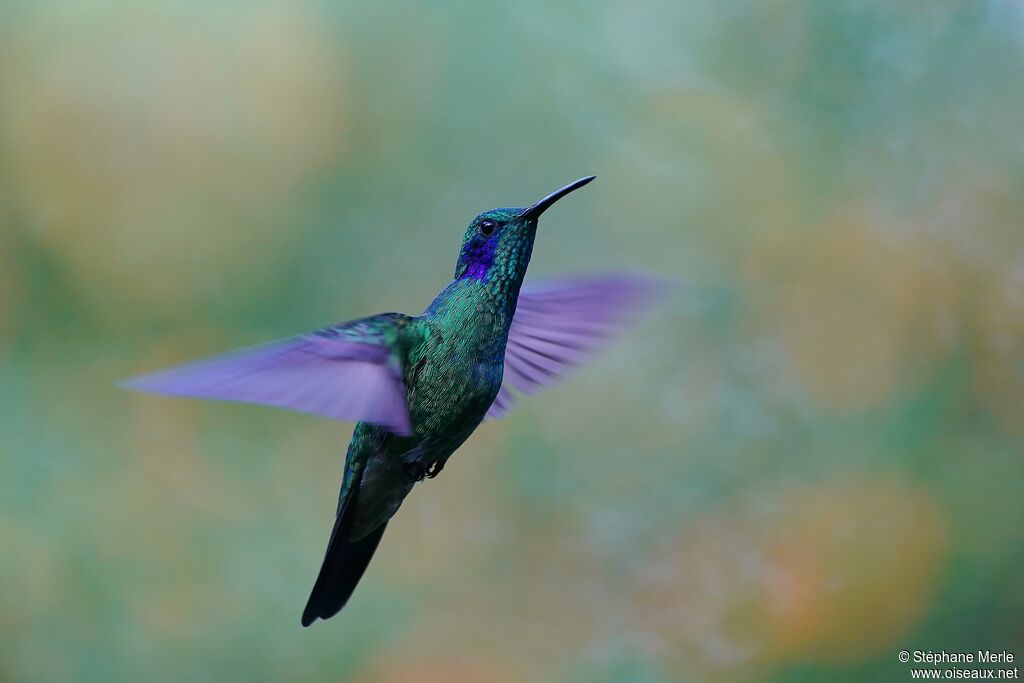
[742,211,963,410]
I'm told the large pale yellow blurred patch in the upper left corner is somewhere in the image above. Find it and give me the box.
[0,0,346,314]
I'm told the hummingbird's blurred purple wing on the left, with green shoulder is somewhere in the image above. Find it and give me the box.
[122,313,412,434]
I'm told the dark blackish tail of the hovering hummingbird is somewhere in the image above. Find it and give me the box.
[302,487,387,627]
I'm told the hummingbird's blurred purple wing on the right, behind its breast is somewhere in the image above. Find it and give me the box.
[487,274,664,418]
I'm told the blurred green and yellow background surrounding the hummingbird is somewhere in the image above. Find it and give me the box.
[0,0,1024,683]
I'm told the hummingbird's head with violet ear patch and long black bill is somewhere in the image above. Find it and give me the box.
[455,175,596,291]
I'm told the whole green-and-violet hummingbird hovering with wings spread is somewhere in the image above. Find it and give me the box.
[124,175,658,627]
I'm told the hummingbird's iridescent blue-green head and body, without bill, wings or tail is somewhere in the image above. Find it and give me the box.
[340,202,537,541]
